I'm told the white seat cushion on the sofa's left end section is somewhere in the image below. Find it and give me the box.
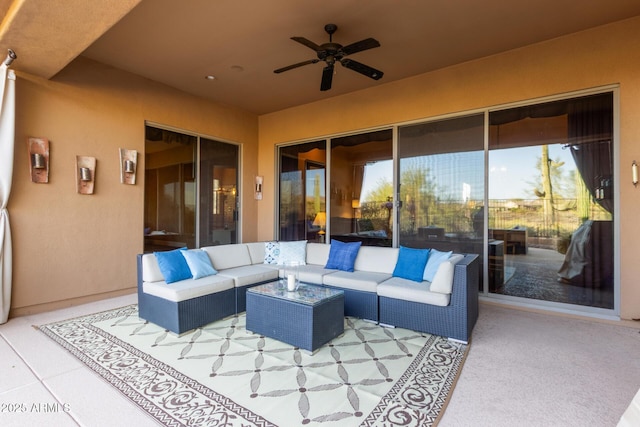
[142,275,234,302]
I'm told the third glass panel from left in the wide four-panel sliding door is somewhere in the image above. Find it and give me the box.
[398,114,484,275]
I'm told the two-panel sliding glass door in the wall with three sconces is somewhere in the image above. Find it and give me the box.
[144,126,239,252]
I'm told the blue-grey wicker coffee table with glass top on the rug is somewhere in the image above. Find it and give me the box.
[247,281,344,352]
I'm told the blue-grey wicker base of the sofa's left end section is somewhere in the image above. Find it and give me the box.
[138,288,236,334]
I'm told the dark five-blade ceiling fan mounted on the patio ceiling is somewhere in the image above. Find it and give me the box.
[273,24,384,90]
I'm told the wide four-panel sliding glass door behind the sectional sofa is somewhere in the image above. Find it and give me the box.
[279,91,616,313]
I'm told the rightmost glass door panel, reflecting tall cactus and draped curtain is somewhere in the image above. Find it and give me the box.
[488,93,614,309]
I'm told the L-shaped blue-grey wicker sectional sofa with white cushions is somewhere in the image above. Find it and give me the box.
[138,242,479,342]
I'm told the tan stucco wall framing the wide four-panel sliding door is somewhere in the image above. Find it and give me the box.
[258,18,640,319]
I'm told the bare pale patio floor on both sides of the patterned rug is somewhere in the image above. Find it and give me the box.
[0,294,640,427]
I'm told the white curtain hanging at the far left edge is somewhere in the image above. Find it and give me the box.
[0,63,16,324]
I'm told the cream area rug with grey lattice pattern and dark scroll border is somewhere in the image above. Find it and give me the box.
[39,305,468,427]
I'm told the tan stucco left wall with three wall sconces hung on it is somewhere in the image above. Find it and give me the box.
[8,58,258,316]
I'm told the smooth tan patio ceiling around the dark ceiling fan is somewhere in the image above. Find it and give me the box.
[0,0,640,114]
